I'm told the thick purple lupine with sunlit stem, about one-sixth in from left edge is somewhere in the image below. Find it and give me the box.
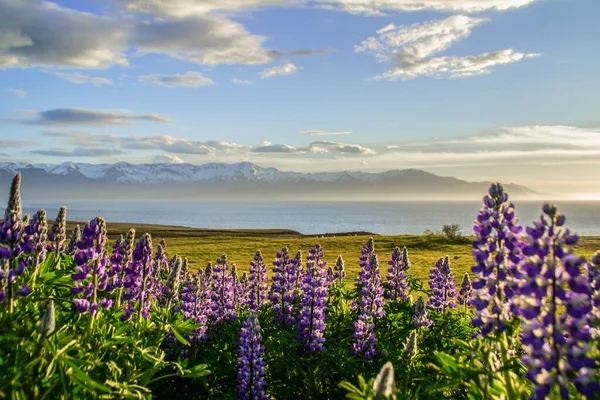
[71,217,112,317]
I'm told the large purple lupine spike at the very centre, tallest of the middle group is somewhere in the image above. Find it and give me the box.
[297,244,328,353]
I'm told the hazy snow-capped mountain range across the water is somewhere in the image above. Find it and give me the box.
[0,162,540,201]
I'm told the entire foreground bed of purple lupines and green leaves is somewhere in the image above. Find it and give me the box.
[0,175,600,399]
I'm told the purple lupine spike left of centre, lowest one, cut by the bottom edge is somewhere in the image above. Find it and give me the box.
[237,311,267,400]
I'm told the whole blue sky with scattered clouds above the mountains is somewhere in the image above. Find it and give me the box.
[0,0,600,196]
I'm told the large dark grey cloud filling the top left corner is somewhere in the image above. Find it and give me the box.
[0,0,127,69]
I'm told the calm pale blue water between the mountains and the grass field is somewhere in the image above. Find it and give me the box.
[17,201,600,235]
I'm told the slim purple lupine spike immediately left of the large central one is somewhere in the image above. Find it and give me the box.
[270,246,295,325]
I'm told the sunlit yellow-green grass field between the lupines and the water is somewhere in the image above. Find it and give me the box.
[69,222,600,284]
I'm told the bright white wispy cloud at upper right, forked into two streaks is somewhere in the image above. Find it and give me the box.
[354,15,538,80]
